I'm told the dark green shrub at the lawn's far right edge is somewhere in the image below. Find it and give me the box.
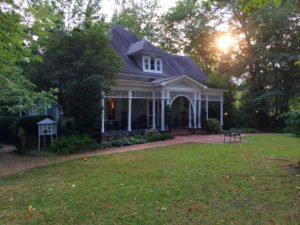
[281,109,300,134]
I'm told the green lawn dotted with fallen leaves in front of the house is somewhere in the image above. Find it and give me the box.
[0,134,300,225]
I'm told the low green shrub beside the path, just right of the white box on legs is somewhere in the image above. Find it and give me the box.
[46,135,95,154]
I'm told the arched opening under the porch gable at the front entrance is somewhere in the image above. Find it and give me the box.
[170,96,194,128]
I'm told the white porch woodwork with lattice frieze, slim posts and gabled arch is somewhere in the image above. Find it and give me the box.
[101,75,224,133]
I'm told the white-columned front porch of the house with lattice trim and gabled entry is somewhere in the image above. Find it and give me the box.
[101,77,224,133]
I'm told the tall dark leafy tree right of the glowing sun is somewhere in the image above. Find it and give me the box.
[234,1,300,126]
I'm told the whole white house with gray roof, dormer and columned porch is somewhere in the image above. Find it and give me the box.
[101,26,225,133]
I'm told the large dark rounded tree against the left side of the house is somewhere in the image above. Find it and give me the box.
[35,22,120,132]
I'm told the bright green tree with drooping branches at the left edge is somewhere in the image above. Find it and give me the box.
[0,1,55,114]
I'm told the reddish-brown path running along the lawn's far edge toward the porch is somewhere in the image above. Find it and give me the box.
[0,135,239,177]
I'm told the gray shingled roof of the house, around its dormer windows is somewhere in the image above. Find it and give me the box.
[111,25,207,83]
